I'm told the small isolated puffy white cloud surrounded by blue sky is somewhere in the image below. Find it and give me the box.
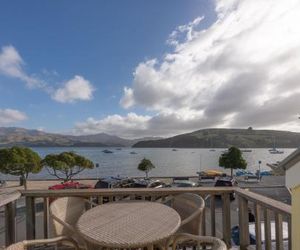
[52,75,94,103]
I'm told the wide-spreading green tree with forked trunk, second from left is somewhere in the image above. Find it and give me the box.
[42,152,94,182]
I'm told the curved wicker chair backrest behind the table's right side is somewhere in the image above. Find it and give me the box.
[172,193,205,235]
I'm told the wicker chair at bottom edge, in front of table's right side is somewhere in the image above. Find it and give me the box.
[172,234,227,250]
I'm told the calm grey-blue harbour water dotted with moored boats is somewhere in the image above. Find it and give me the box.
[2,147,294,179]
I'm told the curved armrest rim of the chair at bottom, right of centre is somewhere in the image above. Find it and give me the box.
[172,233,227,250]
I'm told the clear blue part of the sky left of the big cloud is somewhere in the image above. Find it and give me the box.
[0,0,213,135]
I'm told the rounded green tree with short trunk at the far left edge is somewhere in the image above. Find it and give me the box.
[0,147,42,189]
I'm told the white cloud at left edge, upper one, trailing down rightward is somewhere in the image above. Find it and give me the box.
[0,45,44,88]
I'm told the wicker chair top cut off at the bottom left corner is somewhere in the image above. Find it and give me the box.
[6,236,79,250]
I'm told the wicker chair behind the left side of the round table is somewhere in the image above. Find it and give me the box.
[49,197,93,249]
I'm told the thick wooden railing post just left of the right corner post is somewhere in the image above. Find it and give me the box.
[222,193,231,248]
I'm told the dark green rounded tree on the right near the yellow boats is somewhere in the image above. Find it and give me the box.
[219,147,247,177]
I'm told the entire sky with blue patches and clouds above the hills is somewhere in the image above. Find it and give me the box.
[0,0,300,138]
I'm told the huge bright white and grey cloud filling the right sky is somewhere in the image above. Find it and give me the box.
[115,0,300,137]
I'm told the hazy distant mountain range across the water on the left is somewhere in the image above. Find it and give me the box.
[0,127,161,147]
